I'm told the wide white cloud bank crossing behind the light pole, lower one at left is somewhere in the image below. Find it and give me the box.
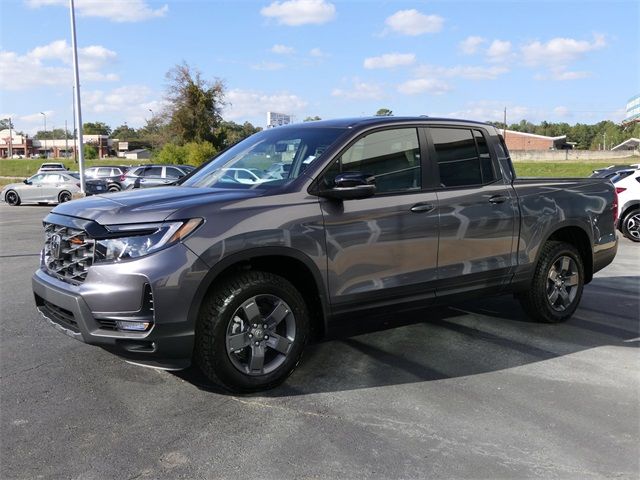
[0,40,118,90]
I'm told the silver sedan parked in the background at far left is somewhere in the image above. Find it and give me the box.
[0,172,80,206]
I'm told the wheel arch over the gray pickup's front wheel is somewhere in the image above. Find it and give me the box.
[189,247,330,338]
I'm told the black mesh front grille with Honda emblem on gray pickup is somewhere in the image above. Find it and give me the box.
[44,223,95,285]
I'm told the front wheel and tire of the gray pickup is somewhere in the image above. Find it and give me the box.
[195,271,309,392]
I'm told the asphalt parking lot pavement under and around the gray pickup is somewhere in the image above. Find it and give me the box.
[0,204,640,479]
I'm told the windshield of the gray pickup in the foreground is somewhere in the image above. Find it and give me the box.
[182,127,346,188]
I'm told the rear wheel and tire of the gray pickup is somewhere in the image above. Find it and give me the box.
[518,241,584,323]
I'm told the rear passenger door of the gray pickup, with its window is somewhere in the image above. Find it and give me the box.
[427,126,518,295]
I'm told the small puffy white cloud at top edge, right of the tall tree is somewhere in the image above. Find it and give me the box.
[260,0,336,27]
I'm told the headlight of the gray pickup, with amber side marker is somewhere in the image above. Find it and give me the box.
[94,218,202,262]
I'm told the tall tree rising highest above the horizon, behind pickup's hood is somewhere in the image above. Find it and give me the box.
[166,63,225,146]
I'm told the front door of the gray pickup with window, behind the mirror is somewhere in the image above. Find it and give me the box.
[320,127,438,313]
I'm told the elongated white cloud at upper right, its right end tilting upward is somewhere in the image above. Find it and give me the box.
[521,35,607,67]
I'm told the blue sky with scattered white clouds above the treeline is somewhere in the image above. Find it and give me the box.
[0,0,640,134]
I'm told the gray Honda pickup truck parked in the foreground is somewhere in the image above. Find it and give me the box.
[33,117,617,392]
